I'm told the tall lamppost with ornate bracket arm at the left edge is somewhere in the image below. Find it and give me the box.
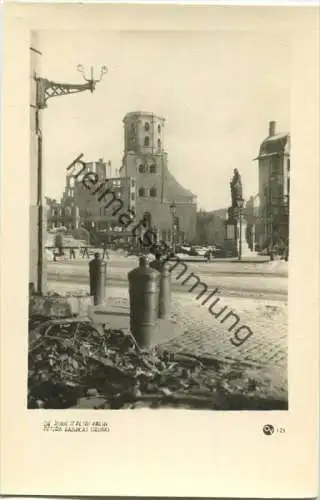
[34,64,108,294]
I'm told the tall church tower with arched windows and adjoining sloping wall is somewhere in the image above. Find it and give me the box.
[120,111,197,242]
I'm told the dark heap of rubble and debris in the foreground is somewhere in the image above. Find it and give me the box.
[28,316,285,410]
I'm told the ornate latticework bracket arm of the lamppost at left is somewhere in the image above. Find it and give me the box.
[35,77,96,109]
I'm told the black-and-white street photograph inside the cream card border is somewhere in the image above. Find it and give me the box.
[27,26,291,411]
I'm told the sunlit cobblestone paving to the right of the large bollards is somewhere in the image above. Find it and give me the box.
[165,297,287,367]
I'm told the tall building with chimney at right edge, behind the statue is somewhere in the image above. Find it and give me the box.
[256,121,290,249]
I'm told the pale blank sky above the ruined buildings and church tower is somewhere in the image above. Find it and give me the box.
[39,31,290,210]
